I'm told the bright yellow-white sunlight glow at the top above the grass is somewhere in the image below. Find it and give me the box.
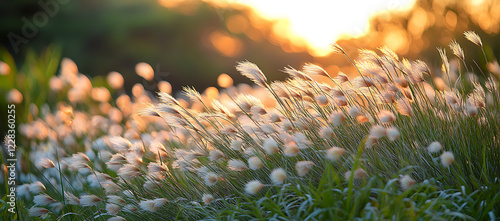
[225,0,416,56]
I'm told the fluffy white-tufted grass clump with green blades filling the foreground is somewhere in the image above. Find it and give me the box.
[4,32,500,221]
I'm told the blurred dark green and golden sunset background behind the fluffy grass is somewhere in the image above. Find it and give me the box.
[0,0,500,129]
